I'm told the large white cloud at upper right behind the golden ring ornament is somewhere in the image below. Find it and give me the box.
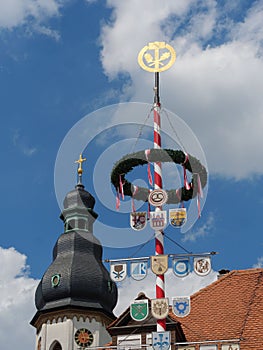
[98,0,263,179]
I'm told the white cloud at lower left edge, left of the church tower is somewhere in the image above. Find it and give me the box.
[0,247,38,350]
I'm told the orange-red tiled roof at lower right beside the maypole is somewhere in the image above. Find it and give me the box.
[171,269,263,350]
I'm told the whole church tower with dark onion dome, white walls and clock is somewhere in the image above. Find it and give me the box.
[31,155,117,350]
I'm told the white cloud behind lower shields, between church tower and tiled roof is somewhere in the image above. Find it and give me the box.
[114,269,217,315]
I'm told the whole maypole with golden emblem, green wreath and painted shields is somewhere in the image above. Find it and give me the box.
[110,42,213,350]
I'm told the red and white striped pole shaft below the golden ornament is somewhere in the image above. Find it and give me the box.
[153,72,166,332]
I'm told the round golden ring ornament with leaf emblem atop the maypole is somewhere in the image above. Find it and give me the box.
[138,41,176,73]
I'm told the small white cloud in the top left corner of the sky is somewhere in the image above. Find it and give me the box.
[0,0,62,30]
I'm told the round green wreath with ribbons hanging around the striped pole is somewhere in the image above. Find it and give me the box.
[111,149,207,204]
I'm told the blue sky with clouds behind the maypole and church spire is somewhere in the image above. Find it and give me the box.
[0,0,263,349]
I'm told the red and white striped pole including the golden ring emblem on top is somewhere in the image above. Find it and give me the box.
[138,42,175,332]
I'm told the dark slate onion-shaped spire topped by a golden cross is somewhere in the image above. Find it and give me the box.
[35,156,117,316]
